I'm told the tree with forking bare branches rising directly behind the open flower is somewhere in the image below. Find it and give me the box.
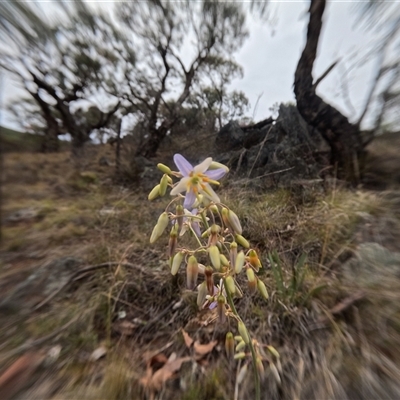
[111,0,247,157]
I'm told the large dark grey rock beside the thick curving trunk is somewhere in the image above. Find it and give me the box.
[216,105,329,186]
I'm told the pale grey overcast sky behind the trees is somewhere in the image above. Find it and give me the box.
[0,0,390,128]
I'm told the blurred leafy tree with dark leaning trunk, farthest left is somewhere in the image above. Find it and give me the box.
[0,0,124,151]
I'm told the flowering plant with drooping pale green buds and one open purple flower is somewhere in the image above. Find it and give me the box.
[149,154,277,399]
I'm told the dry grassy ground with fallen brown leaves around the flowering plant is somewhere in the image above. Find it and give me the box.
[0,136,400,400]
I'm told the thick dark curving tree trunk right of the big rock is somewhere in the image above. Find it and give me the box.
[294,0,364,183]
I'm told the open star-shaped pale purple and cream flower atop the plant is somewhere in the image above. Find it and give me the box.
[171,154,228,209]
